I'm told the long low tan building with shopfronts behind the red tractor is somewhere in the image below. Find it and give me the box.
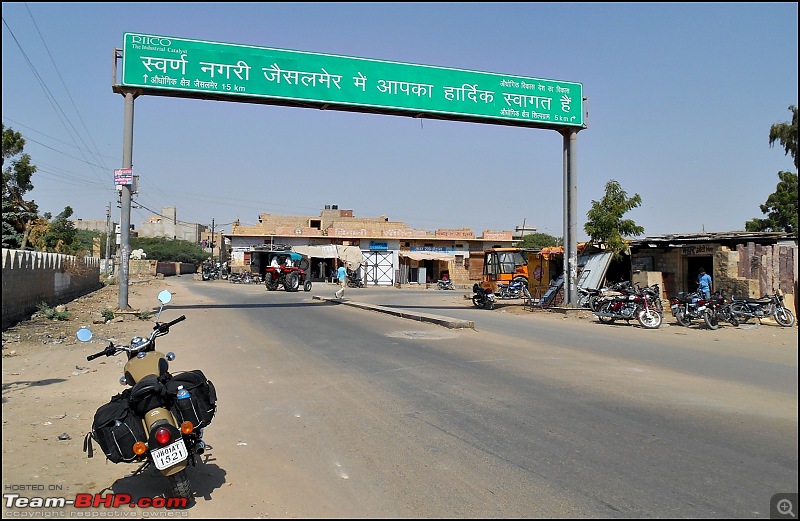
[225,205,513,285]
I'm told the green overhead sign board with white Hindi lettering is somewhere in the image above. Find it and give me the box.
[122,33,584,127]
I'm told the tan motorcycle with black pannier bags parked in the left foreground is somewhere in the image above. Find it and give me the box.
[76,290,217,500]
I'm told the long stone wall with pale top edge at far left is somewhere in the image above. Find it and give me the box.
[2,249,103,330]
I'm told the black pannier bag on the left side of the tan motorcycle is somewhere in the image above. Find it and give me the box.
[83,390,147,463]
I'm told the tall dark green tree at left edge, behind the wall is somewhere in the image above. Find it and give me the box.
[2,125,39,249]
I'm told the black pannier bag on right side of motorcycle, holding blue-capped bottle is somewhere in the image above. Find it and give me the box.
[167,369,217,429]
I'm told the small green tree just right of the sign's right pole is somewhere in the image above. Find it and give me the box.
[583,179,644,258]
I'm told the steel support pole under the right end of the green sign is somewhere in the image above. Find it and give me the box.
[561,129,578,307]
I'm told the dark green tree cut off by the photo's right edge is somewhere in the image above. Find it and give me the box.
[744,105,797,234]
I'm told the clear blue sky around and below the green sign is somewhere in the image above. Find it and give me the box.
[2,2,798,240]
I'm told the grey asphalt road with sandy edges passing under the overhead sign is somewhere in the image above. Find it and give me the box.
[170,281,797,517]
